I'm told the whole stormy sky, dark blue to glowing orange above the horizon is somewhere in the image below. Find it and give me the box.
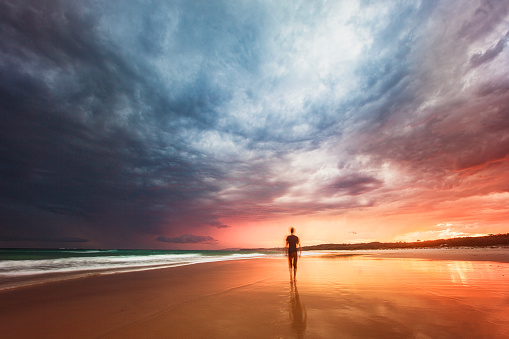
[0,0,509,249]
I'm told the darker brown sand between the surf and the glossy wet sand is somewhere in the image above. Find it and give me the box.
[0,259,286,338]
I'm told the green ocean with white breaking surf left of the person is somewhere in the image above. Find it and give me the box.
[0,249,282,290]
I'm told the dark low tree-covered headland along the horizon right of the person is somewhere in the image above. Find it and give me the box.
[302,233,509,251]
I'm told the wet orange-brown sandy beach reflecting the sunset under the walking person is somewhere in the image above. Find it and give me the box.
[0,248,509,338]
